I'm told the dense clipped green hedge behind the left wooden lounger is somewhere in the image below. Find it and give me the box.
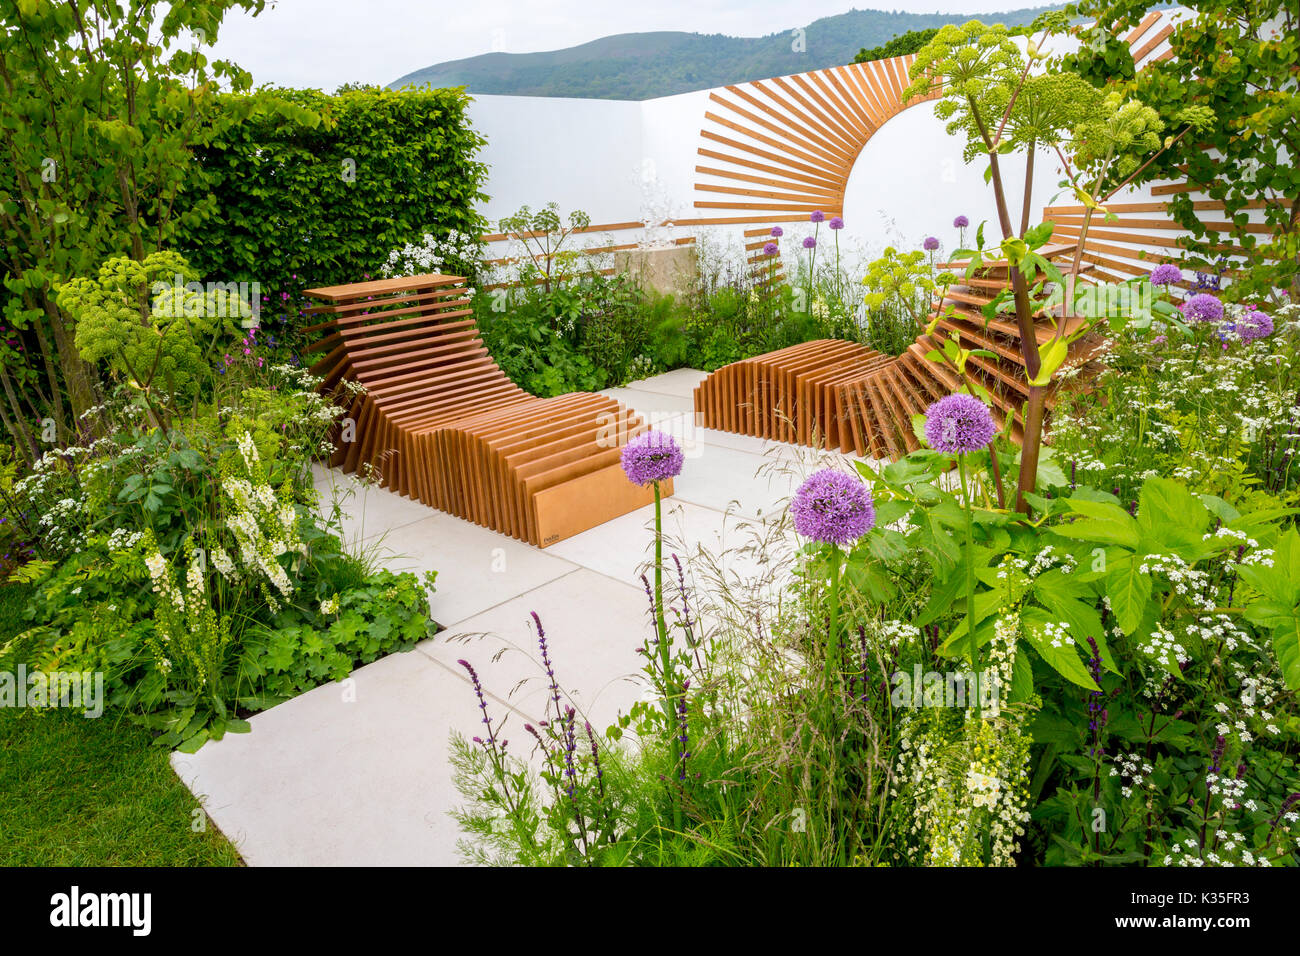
[179,87,488,302]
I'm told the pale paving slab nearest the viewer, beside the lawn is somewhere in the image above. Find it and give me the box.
[172,650,476,866]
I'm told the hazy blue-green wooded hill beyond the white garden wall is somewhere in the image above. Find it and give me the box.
[389,7,1071,100]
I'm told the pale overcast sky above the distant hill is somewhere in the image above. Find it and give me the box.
[208,0,1049,91]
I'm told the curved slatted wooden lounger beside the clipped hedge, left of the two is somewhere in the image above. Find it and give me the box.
[306,274,672,548]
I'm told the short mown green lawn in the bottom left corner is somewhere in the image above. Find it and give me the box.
[0,585,241,866]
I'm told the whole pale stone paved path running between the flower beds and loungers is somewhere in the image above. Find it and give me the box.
[172,369,863,866]
